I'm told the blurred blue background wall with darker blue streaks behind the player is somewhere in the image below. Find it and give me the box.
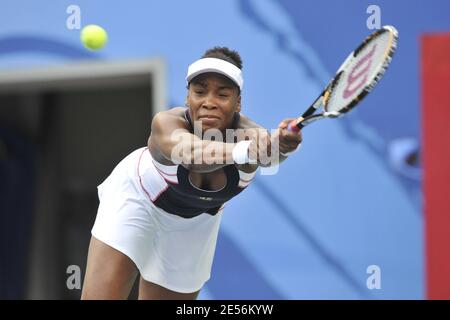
[0,0,450,299]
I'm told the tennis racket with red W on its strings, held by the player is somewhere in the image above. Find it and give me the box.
[288,26,398,132]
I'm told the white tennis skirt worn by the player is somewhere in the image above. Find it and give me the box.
[92,148,222,293]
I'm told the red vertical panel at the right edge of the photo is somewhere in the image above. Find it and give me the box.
[421,33,450,299]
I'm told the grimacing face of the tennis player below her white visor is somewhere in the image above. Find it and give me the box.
[187,73,241,132]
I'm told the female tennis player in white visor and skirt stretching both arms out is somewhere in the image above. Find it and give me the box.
[82,47,302,299]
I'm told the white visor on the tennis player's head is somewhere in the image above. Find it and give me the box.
[186,58,244,91]
